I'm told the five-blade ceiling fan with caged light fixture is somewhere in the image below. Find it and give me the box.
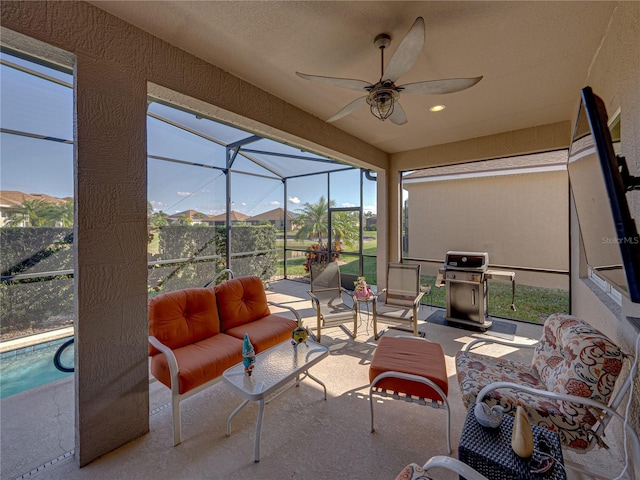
[296,17,482,125]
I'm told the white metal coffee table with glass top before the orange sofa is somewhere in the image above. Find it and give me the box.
[222,340,329,462]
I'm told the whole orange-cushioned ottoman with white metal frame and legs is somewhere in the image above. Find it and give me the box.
[369,336,451,453]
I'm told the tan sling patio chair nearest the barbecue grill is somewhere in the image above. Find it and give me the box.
[373,263,424,340]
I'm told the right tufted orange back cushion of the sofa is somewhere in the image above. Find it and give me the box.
[215,277,271,332]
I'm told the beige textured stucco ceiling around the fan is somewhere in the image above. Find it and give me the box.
[90,1,616,152]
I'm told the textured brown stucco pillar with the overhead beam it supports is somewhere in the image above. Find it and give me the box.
[0,1,388,465]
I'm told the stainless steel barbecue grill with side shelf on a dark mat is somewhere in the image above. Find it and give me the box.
[442,251,516,330]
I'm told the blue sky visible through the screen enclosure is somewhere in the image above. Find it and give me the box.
[0,53,375,215]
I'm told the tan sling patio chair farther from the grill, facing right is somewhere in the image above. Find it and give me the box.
[308,262,358,342]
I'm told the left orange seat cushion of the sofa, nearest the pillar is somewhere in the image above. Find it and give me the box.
[151,333,242,394]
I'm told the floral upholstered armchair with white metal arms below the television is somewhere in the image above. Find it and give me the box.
[456,314,638,464]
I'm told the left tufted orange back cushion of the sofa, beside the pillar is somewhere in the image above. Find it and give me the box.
[149,288,220,355]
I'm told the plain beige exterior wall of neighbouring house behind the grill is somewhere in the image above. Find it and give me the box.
[405,171,569,288]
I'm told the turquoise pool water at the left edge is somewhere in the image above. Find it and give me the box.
[0,338,73,398]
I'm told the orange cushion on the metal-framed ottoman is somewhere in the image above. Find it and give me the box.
[369,337,449,400]
